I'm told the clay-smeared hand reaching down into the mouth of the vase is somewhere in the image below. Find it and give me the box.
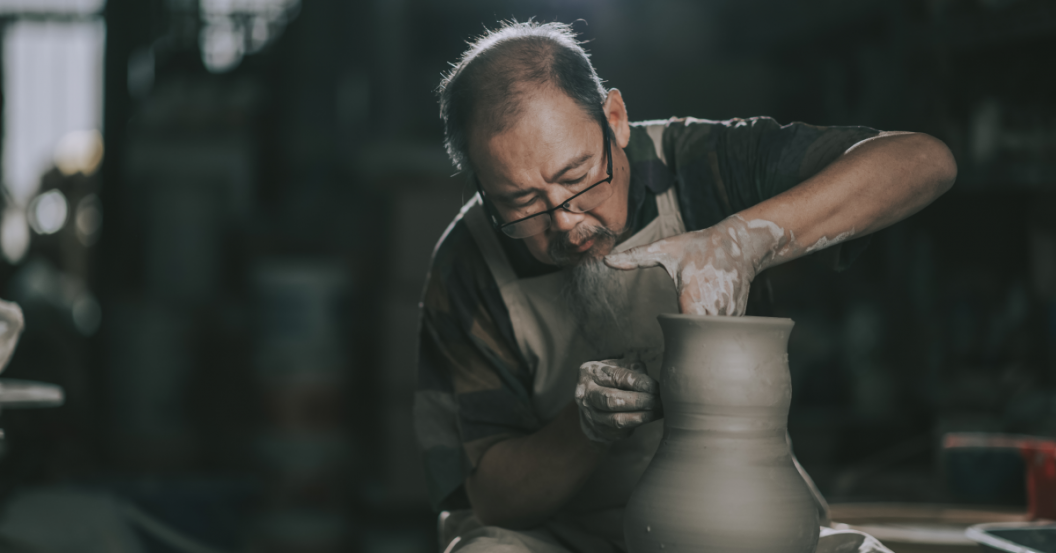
[605,215,793,316]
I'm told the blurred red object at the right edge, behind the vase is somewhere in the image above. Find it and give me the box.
[942,433,1056,520]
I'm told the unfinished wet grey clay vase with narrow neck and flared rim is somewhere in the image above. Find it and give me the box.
[623,314,818,553]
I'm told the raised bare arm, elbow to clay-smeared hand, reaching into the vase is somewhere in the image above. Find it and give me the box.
[605,133,957,316]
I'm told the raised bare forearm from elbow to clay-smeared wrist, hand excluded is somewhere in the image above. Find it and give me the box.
[738,133,957,270]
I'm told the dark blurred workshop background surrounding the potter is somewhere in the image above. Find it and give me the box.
[0,0,1056,553]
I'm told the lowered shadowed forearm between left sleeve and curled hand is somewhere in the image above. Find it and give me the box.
[466,403,605,528]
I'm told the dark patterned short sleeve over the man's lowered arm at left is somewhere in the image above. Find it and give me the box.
[414,216,540,511]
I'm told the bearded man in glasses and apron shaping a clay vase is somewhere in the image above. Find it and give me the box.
[415,22,957,552]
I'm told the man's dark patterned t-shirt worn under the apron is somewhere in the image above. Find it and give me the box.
[414,117,878,510]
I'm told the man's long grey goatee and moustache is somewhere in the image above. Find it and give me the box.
[547,221,630,347]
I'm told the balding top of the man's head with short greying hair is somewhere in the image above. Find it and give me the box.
[438,21,606,170]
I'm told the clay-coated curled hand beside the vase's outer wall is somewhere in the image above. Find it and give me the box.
[576,359,662,443]
